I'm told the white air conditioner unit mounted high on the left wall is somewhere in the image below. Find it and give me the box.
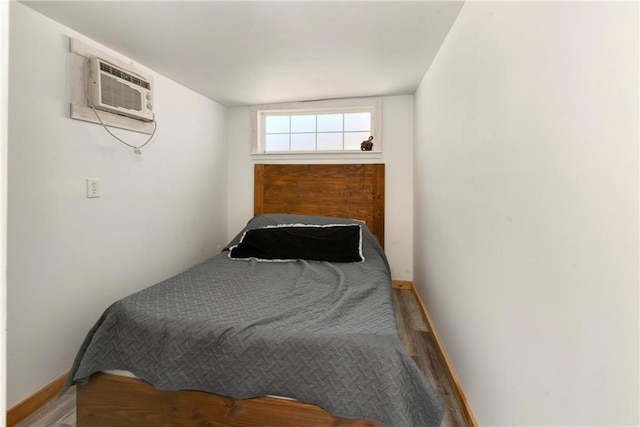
[87,58,153,122]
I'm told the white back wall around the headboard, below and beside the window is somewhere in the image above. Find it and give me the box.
[228,95,413,280]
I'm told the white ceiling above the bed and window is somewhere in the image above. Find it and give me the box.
[21,0,463,106]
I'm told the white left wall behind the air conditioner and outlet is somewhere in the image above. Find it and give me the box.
[7,2,227,407]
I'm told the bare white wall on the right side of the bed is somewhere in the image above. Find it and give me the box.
[414,2,640,426]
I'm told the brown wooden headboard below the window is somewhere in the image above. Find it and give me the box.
[253,163,384,248]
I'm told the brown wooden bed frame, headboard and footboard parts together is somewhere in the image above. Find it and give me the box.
[77,164,384,427]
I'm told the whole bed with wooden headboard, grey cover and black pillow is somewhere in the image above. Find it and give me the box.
[67,164,443,426]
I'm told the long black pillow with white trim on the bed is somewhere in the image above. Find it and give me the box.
[229,224,364,262]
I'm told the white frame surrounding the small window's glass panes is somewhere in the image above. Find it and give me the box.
[251,98,382,160]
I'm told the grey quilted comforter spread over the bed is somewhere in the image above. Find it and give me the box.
[67,215,443,426]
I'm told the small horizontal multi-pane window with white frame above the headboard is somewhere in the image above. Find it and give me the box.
[252,98,382,155]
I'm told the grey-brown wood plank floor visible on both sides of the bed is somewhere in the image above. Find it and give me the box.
[17,289,467,427]
